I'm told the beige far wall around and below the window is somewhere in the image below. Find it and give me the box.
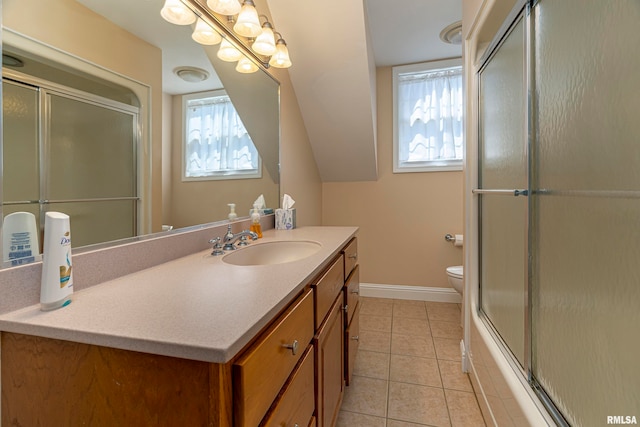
[322,67,463,287]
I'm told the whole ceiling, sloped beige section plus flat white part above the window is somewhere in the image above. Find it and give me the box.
[267,0,462,182]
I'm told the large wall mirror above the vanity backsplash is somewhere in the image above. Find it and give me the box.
[1,0,280,267]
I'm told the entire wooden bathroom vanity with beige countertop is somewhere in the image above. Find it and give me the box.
[0,227,359,427]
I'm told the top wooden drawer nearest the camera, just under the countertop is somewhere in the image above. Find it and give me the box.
[233,290,314,427]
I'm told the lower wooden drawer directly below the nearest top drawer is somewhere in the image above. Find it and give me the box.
[262,346,316,427]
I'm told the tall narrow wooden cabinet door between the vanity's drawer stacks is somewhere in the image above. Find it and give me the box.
[315,293,344,427]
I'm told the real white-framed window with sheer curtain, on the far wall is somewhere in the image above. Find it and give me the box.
[393,60,464,173]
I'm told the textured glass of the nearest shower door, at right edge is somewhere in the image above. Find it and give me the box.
[532,0,640,426]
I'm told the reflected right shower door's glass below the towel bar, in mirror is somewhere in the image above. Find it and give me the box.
[47,201,136,247]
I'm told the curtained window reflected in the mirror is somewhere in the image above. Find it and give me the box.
[182,90,262,181]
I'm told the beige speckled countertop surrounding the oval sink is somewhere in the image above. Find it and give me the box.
[0,227,357,363]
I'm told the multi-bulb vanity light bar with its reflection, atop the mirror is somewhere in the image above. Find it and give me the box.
[160,0,291,72]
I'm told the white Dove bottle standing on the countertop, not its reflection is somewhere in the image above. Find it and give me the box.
[40,212,73,311]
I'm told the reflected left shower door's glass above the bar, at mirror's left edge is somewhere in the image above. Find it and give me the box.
[2,82,40,202]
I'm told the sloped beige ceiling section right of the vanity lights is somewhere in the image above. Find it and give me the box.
[268,0,377,182]
